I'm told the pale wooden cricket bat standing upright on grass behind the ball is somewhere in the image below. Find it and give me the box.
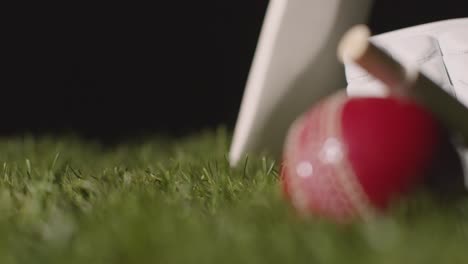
[229,0,372,165]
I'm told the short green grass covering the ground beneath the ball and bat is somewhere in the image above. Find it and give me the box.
[0,127,468,264]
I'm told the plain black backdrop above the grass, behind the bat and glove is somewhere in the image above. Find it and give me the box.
[0,0,468,141]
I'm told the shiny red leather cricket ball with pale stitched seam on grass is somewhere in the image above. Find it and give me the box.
[281,93,442,221]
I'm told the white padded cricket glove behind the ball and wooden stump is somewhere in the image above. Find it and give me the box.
[345,18,468,187]
